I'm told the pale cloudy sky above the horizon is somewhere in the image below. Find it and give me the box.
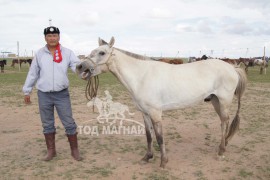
[0,0,270,58]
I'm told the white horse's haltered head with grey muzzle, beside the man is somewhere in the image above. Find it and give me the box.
[76,37,114,80]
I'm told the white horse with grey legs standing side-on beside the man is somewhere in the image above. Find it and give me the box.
[77,37,247,168]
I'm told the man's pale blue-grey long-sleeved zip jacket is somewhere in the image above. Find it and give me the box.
[23,46,80,95]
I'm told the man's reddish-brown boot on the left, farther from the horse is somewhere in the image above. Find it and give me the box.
[43,132,56,161]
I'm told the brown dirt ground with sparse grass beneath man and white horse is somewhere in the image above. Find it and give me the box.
[0,79,270,180]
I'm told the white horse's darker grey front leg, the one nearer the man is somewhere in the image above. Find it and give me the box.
[142,114,153,162]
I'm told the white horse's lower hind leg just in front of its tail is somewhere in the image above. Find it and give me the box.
[211,95,229,156]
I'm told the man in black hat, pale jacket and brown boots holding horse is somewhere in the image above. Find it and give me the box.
[23,26,82,161]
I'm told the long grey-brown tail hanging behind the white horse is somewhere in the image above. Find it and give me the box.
[225,68,247,144]
